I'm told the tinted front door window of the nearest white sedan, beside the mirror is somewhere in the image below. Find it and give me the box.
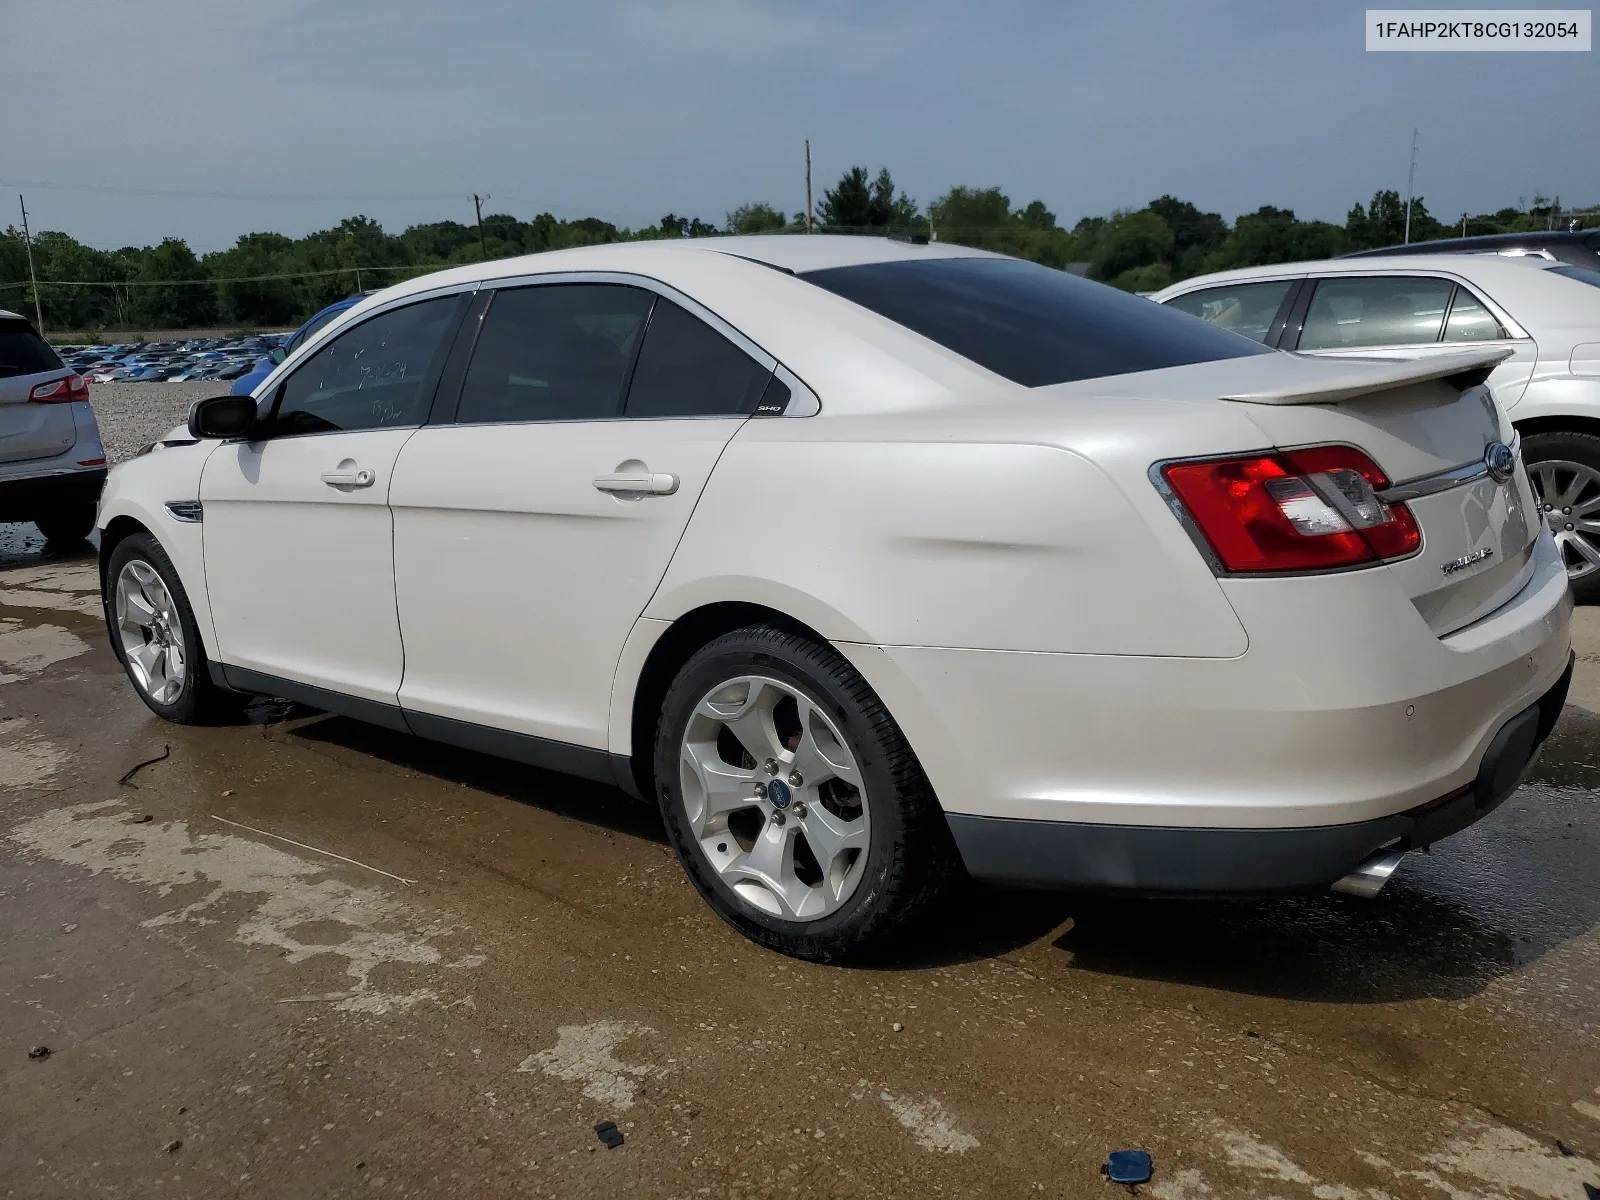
[275,296,458,434]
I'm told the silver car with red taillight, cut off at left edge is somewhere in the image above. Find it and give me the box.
[0,309,106,542]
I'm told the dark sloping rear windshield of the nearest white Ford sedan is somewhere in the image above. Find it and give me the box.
[800,258,1274,387]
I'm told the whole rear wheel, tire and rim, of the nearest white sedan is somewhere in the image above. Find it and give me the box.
[656,626,957,962]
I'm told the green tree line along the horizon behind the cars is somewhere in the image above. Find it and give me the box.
[0,166,1570,331]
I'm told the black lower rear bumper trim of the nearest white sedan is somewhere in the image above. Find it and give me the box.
[947,656,1573,894]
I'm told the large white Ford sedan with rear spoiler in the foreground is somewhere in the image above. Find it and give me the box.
[99,237,1571,960]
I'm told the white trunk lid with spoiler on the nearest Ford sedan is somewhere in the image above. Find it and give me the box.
[1222,349,1541,635]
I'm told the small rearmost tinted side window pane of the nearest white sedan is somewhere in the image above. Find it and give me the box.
[627,299,773,416]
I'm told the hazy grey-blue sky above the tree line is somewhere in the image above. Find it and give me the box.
[0,0,1600,251]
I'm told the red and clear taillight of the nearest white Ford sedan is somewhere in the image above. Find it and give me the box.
[1162,446,1422,571]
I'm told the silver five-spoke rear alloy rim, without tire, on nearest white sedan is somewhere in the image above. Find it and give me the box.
[680,675,872,922]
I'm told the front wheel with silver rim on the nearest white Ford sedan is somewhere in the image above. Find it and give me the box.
[104,533,240,725]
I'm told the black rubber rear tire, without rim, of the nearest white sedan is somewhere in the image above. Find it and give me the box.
[654,626,960,963]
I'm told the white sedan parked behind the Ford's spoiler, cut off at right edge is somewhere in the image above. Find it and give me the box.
[1152,253,1600,602]
